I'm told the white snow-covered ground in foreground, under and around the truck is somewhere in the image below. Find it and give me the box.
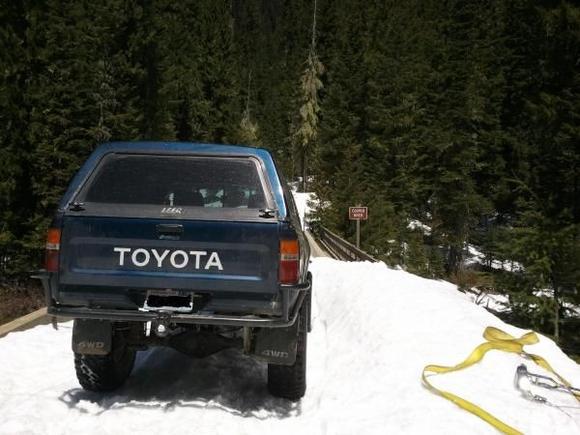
[0,258,580,435]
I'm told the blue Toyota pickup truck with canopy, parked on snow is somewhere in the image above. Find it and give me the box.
[41,142,312,400]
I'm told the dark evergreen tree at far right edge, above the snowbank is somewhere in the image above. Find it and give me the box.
[500,2,580,339]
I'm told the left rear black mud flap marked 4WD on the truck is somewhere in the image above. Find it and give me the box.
[72,319,113,355]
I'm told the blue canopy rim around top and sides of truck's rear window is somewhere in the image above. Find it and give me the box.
[58,141,287,218]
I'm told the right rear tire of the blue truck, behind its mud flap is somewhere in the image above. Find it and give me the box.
[268,300,308,401]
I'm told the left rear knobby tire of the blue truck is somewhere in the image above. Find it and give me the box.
[75,324,136,391]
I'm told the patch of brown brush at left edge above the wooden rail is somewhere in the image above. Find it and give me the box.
[0,285,45,325]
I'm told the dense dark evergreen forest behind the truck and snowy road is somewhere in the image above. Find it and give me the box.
[0,0,580,350]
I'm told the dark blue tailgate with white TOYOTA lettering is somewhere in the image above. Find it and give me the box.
[59,216,279,296]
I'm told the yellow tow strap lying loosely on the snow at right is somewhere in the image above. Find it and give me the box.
[422,326,580,435]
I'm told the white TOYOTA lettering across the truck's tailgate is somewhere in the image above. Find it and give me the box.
[113,246,224,270]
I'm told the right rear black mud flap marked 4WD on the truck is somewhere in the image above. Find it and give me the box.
[252,319,300,365]
